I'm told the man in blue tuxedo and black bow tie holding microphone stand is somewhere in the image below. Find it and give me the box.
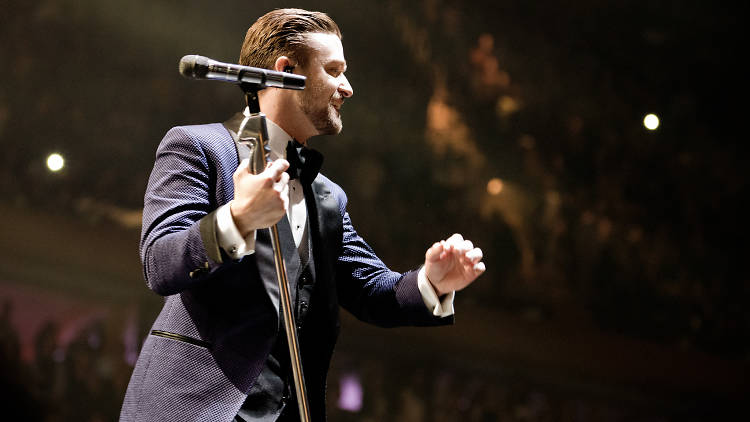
[121,9,484,421]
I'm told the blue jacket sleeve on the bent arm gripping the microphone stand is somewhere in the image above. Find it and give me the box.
[140,127,236,295]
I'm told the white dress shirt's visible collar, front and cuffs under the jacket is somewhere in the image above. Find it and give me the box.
[216,116,455,317]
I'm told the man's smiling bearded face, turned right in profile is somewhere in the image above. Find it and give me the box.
[298,32,354,135]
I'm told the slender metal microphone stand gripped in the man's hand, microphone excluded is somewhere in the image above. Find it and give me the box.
[237,83,310,422]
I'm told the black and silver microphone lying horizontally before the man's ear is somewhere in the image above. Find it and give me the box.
[180,54,307,89]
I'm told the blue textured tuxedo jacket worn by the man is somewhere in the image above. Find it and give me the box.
[120,124,452,421]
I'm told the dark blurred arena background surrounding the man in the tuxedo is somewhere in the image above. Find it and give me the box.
[0,0,750,421]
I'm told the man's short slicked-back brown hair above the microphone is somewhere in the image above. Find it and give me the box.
[240,9,341,69]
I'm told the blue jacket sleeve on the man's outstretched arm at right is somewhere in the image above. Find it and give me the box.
[336,188,453,327]
